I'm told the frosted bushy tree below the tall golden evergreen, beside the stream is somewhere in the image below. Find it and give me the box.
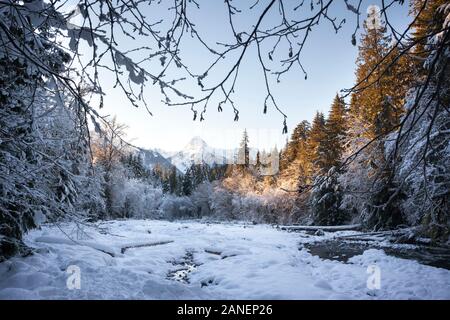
[338,129,403,230]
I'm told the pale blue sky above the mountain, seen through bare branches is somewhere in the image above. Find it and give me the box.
[91,0,409,150]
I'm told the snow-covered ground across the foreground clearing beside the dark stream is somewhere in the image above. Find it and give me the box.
[0,220,450,299]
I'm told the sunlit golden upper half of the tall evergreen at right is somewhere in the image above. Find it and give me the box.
[350,18,411,141]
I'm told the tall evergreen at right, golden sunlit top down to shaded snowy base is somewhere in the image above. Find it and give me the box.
[347,15,411,228]
